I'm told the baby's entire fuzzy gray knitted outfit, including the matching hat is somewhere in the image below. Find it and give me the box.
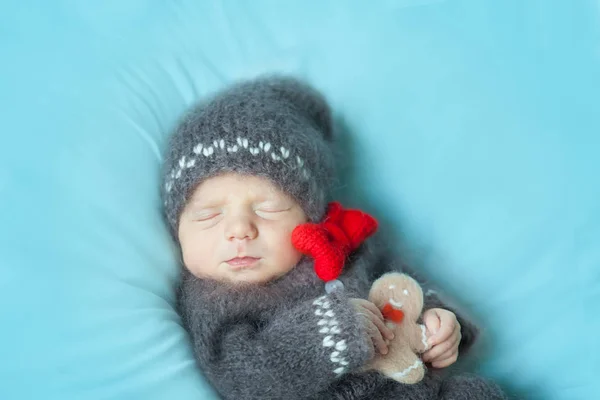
[163,77,505,400]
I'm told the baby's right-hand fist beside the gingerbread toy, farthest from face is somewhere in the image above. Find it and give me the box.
[423,308,462,368]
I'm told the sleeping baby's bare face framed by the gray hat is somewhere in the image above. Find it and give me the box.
[179,174,306,283]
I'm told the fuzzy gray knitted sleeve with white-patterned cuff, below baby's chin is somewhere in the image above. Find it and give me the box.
[181,284,372,400]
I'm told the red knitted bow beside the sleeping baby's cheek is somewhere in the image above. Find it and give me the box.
[292,202,378,281]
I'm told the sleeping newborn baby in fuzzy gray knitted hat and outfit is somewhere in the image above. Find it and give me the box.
[162,76,505,400]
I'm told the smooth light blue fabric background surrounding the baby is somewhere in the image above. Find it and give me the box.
[0,0,600,400]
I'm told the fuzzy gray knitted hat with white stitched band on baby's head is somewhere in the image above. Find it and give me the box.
[162,77,333,237]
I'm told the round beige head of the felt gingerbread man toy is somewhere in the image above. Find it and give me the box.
[378,276,423,316]
